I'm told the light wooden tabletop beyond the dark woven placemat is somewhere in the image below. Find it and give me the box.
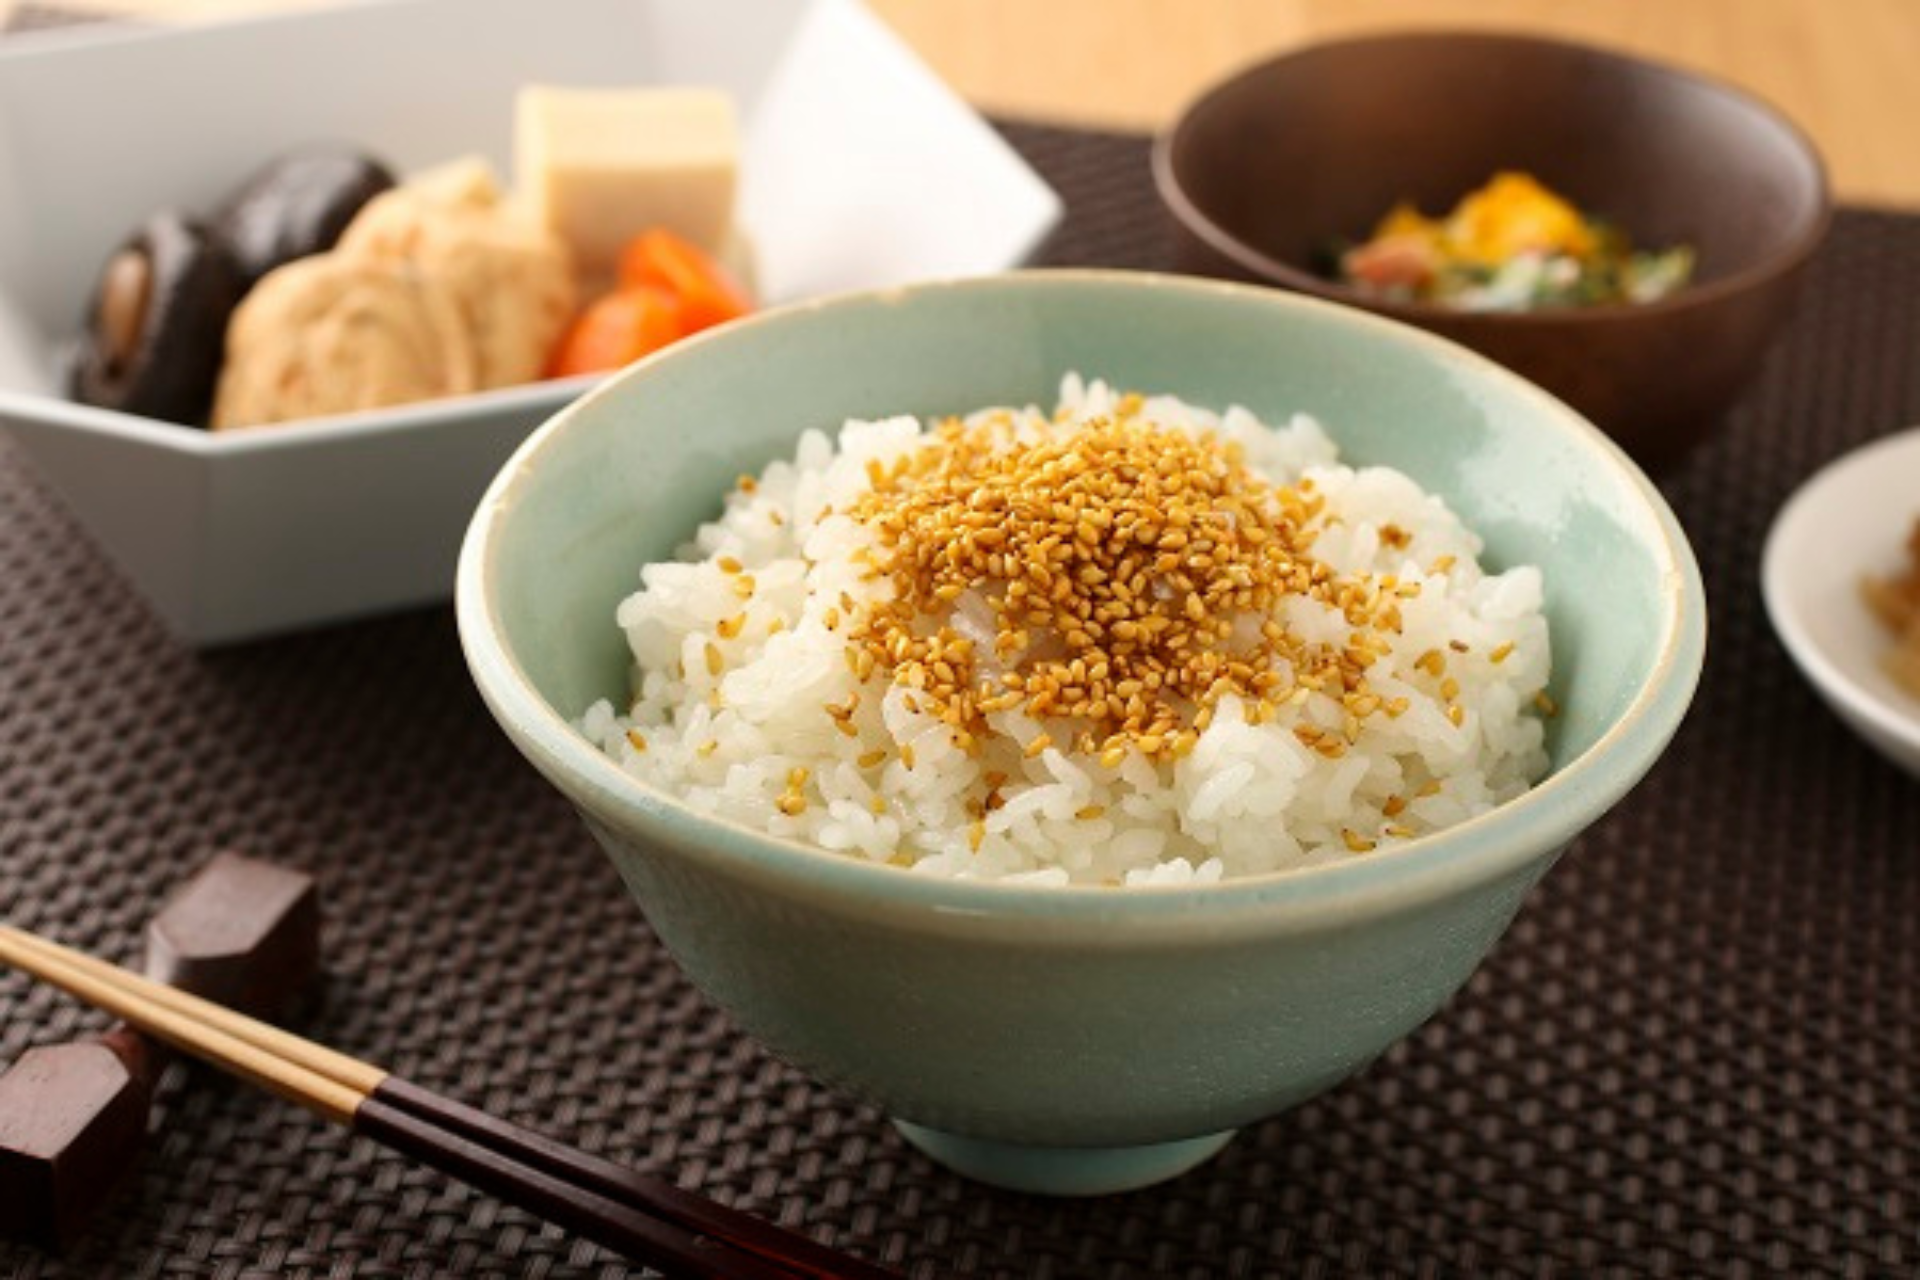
[15,0,1920,209]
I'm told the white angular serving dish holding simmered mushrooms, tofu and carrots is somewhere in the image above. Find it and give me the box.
[0,0,1060,645]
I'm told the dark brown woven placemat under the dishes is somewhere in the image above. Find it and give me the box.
[0,117,1920,1278]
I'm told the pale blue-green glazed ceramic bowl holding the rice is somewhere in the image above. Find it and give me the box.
[457,271,1705,1194]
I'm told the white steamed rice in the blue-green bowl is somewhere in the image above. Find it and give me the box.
[580,374,1548,885]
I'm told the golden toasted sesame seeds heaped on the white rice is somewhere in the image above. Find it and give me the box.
[841,412,1405,768]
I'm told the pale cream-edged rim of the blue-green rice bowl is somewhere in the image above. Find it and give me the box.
[455,269,1707,927]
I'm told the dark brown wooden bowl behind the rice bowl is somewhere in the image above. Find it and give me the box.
[1154,33,1830,468]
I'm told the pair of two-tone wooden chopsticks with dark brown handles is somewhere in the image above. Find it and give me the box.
[0,925,893,1280]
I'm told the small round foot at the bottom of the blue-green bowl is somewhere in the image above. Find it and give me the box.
[893,1121,1235,1196]
